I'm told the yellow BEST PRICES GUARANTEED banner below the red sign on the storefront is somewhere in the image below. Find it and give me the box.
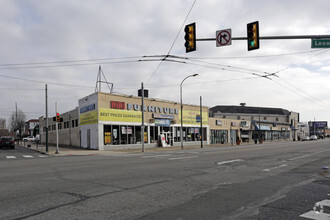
[99,108,142,122]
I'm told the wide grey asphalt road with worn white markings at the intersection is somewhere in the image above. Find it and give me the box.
[0,140,330,220]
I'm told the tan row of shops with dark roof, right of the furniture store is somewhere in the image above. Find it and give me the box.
[210,105,299,144]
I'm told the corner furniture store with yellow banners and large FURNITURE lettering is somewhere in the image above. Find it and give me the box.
[40,92,209,150]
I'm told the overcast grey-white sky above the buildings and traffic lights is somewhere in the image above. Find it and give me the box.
[0,0,330,125]
